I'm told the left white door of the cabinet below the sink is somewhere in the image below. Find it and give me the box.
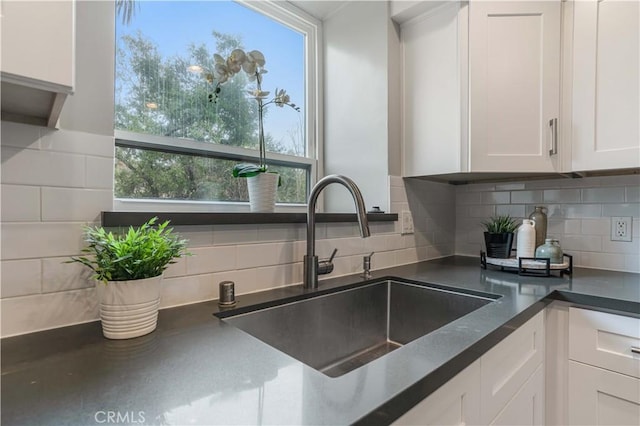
[393,360,480,425]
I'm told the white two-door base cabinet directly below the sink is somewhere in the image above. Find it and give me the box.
[394,312,544,425]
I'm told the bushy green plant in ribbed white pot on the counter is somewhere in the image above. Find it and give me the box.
[69,217,189,339]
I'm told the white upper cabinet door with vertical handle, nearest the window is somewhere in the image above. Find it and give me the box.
[469,1,561,172]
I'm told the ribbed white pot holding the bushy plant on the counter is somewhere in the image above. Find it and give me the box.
[96,275,162,339]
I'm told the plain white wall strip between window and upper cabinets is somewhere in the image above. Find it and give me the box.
[324,1,390,212]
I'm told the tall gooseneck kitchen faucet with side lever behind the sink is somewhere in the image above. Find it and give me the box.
[303,175,371,289]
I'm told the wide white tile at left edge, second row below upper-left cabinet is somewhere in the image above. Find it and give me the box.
[1,145,85,188]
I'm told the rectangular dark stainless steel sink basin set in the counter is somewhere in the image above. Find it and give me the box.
[223,279,499,377]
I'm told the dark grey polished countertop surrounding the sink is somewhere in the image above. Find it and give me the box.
[1,257,640,425]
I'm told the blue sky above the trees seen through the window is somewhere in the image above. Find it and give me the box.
[117,0,304,153]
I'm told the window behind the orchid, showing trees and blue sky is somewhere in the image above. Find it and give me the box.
[115,1,317,210]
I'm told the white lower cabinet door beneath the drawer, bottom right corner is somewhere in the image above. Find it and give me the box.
[569,361,640,426]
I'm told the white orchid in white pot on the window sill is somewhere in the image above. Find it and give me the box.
[205,49,300,212]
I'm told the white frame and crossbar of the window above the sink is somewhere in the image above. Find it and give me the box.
[113,0,323,212]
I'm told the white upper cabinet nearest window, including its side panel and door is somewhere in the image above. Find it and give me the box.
[401,0,562,176]
